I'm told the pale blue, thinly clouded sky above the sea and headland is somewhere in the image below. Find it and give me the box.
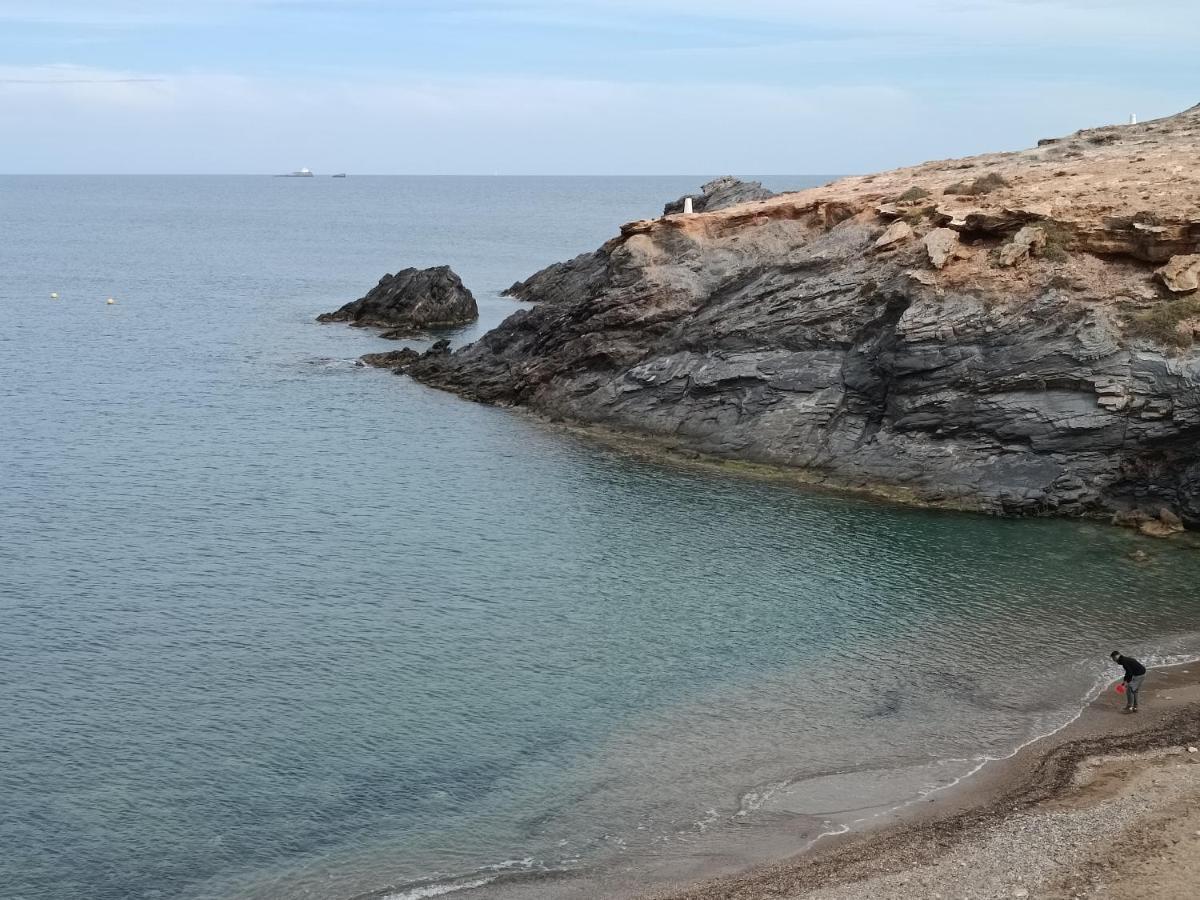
[0,0,1200,176]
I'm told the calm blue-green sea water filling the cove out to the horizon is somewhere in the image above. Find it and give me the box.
[0,176,1200,900]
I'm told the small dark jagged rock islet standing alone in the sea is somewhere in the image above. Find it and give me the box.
[317,265,479,338]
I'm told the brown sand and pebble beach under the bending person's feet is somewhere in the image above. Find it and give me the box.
[655,664,1200,900]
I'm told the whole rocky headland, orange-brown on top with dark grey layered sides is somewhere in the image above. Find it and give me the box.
[407,107,1200,527]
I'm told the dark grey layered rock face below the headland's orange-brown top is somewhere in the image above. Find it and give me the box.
[409,207,1200,528]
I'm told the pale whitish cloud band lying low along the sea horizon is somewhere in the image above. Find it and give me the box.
[0,66,1184,174]
